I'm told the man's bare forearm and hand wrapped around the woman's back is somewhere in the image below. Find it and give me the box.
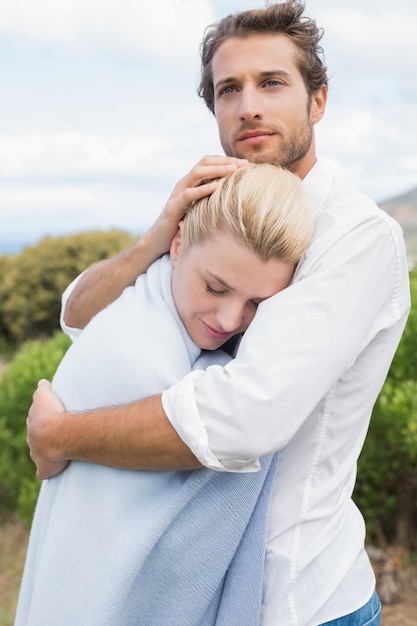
[27,380,201,479]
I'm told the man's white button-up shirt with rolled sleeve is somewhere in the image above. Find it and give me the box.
[163,164,410,626]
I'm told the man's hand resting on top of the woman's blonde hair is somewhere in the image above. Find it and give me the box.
[144,155,248,255]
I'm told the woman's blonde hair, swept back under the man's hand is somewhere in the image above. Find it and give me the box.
[181,163,313,264]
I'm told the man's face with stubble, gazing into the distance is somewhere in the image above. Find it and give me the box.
[212,35,321,176]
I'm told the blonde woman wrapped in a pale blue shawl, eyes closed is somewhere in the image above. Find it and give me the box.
[15,165,313,626]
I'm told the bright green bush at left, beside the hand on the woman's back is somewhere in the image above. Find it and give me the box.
[0,331,70,523]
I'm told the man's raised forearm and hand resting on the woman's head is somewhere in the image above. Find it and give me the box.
[64,156,247,328]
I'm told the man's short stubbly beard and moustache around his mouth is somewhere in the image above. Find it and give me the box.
[220,118,313,170]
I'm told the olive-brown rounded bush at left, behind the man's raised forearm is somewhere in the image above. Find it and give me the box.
[0,230,133,347]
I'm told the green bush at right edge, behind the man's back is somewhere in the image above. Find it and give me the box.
[354,271,417,549]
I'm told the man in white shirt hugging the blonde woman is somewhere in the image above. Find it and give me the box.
[28,0,410,626]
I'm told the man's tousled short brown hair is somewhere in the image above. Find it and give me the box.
[198,0,328,113]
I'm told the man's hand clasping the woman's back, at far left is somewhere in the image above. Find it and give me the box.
[26,380,68,480]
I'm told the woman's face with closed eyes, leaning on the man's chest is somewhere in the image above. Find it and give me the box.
[171,231,294,350]
